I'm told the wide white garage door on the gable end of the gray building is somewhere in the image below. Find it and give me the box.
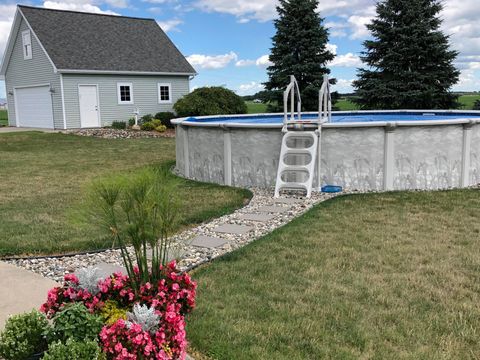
[15,86,53,129]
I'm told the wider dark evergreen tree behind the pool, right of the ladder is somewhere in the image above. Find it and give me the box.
[353,0,460,109]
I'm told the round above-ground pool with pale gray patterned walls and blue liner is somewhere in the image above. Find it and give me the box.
[172,111,480,191]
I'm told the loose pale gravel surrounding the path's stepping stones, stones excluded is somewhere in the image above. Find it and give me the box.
[3,189,342,282]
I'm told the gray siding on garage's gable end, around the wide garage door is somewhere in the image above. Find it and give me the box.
[5,19,63,129]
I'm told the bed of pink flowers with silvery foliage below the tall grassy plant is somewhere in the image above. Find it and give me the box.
[41,262,196,359]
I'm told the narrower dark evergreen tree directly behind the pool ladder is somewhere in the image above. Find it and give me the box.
[264,0,334,110]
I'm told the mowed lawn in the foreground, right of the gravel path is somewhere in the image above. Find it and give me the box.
[187,190,480,360]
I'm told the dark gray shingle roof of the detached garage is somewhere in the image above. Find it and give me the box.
[19,5,195,74]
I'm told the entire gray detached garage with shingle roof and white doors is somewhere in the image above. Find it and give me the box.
[0,6,195,129]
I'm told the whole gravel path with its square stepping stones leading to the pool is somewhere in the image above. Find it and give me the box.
[7,189,344,281]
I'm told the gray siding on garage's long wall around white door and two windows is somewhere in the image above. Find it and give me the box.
[63,74,189,128]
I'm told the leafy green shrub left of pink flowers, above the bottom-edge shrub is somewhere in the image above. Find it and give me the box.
[48,303,103,342]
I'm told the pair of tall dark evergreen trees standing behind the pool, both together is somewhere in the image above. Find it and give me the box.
[259,0,460,111]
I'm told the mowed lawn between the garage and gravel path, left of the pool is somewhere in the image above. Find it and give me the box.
[0,132,250,256]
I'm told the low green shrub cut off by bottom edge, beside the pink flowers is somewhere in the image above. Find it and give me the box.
[43,339,105,360]
